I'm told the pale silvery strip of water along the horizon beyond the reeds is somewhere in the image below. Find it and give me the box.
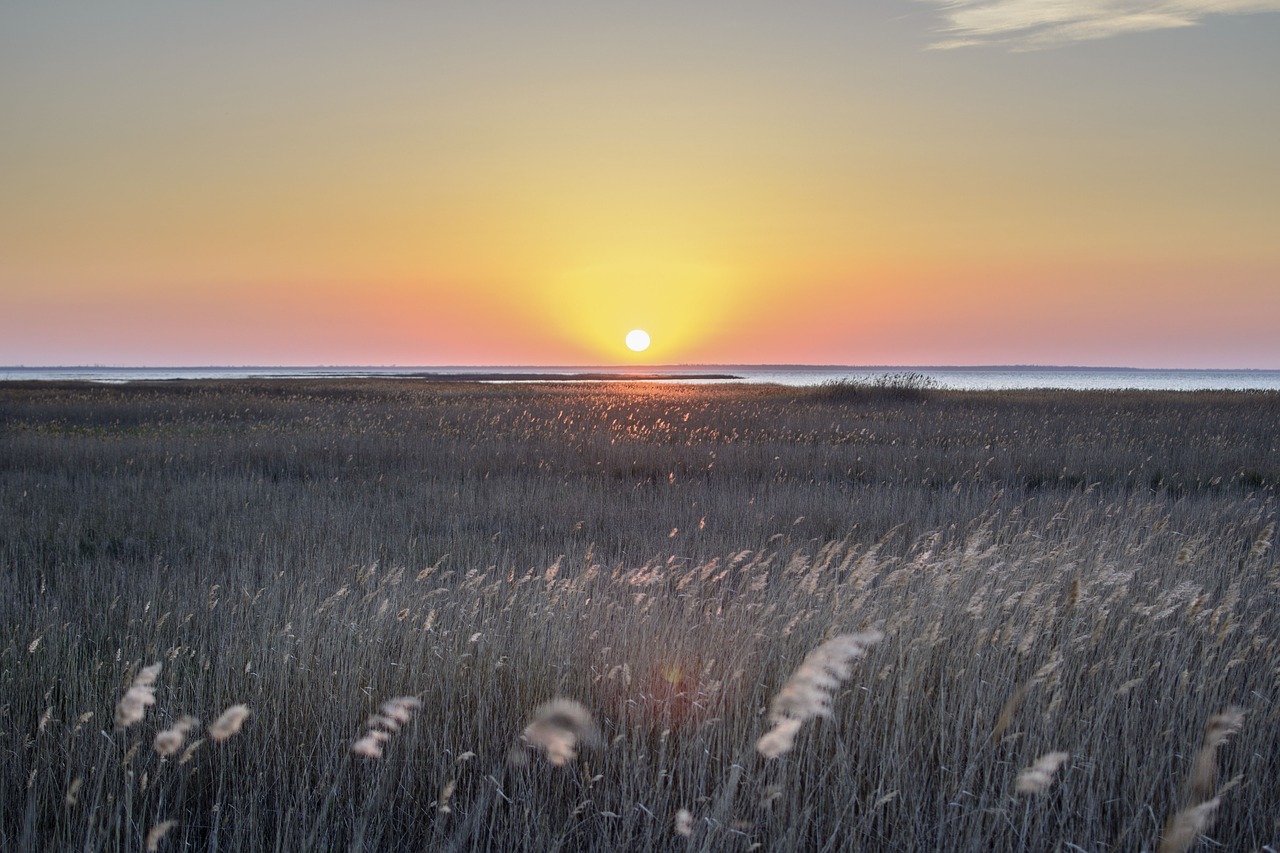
[0,365,1280,391]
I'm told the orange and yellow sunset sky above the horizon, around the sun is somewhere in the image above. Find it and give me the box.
[0,0,1280,369]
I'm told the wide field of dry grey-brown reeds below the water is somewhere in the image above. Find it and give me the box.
[0,380,1280,853]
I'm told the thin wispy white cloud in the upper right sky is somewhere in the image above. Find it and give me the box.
[924,0,1280,50]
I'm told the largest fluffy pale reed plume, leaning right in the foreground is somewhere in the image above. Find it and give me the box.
[755,630,884,758]
